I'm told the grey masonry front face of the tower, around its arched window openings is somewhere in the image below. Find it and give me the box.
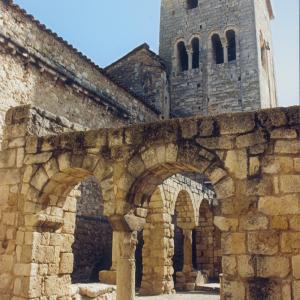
[160,0,274,116]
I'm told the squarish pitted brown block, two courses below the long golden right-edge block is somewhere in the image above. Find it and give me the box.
[248,230,279,255]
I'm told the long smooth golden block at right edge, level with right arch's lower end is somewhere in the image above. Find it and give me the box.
[258,194,299,216]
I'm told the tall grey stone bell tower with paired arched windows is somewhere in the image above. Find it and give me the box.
[160,0,277,116]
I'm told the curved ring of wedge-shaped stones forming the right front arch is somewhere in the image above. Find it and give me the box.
[126,141,235,208]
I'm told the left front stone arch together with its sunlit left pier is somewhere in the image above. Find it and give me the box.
[19,152,111,297]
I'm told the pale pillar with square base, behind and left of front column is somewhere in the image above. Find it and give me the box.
[99,231,121,285]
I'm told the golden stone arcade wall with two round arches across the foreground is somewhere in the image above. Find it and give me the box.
[0,106,300,300]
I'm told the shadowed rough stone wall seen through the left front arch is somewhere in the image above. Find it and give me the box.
[72,178,112,283]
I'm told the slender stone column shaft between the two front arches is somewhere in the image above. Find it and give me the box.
[117,231,137,300]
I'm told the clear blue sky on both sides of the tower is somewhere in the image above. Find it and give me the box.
[15,0,299,106]
